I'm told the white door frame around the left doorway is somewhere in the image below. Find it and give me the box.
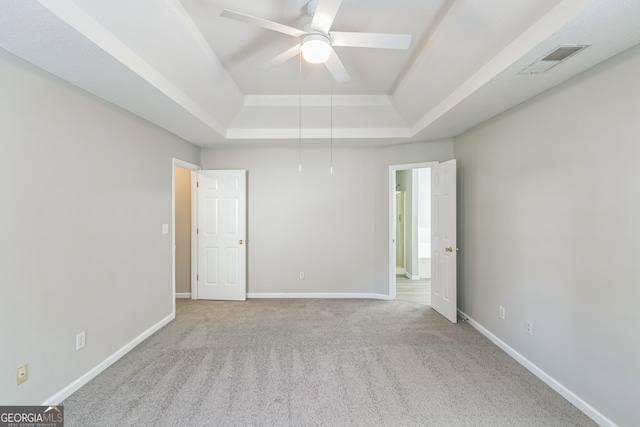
[171,157,202,316]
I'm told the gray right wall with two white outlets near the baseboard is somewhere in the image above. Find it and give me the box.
[455,44,640,426]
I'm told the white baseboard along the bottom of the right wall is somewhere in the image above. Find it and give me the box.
[458,310,617,427]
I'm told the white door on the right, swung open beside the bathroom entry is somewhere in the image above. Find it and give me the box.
[431,159,458,323]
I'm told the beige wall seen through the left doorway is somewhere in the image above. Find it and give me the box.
[174,166,191,294]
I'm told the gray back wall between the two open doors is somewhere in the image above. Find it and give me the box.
[201,141,453,295]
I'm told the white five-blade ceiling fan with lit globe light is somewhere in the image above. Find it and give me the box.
[221,0,411,83]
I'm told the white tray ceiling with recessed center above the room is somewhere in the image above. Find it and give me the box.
[0,0,640,147]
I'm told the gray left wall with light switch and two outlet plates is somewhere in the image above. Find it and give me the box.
[0,49,199,404]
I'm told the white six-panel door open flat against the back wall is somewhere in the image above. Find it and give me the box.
[196,170,247,301]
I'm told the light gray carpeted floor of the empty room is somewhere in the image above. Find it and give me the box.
[63,299,595,427]
